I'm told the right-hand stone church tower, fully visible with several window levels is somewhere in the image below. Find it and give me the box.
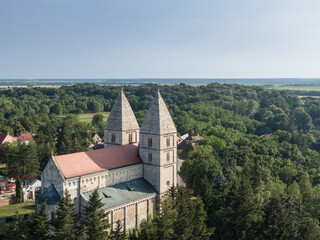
[139,91,177,194]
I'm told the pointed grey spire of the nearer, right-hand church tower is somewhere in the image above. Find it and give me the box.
[140,90,177,135]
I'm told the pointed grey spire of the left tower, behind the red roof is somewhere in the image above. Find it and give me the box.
[104,88,139,131]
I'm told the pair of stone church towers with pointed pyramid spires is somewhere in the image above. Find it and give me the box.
[104,90,177,194]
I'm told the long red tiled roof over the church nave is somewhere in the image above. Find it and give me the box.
[55,144,142,178]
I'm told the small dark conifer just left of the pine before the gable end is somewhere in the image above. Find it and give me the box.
[28,202,49,240]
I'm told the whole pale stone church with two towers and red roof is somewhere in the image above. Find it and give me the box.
[36,90,181,231]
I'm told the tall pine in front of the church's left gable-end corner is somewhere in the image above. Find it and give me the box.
[52,191,79,240]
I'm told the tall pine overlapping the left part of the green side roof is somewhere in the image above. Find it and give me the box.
[84,189,110,240]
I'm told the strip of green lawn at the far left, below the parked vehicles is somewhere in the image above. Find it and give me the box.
[0,201,35,219]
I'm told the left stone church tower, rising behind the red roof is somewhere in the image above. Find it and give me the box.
[104,89,139,148]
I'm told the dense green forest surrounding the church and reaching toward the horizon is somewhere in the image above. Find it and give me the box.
[0,83,320,239]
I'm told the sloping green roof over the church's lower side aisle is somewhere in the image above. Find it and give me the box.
[81,178,157,209]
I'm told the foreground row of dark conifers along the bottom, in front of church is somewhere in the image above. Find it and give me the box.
[4,187,214,240]
